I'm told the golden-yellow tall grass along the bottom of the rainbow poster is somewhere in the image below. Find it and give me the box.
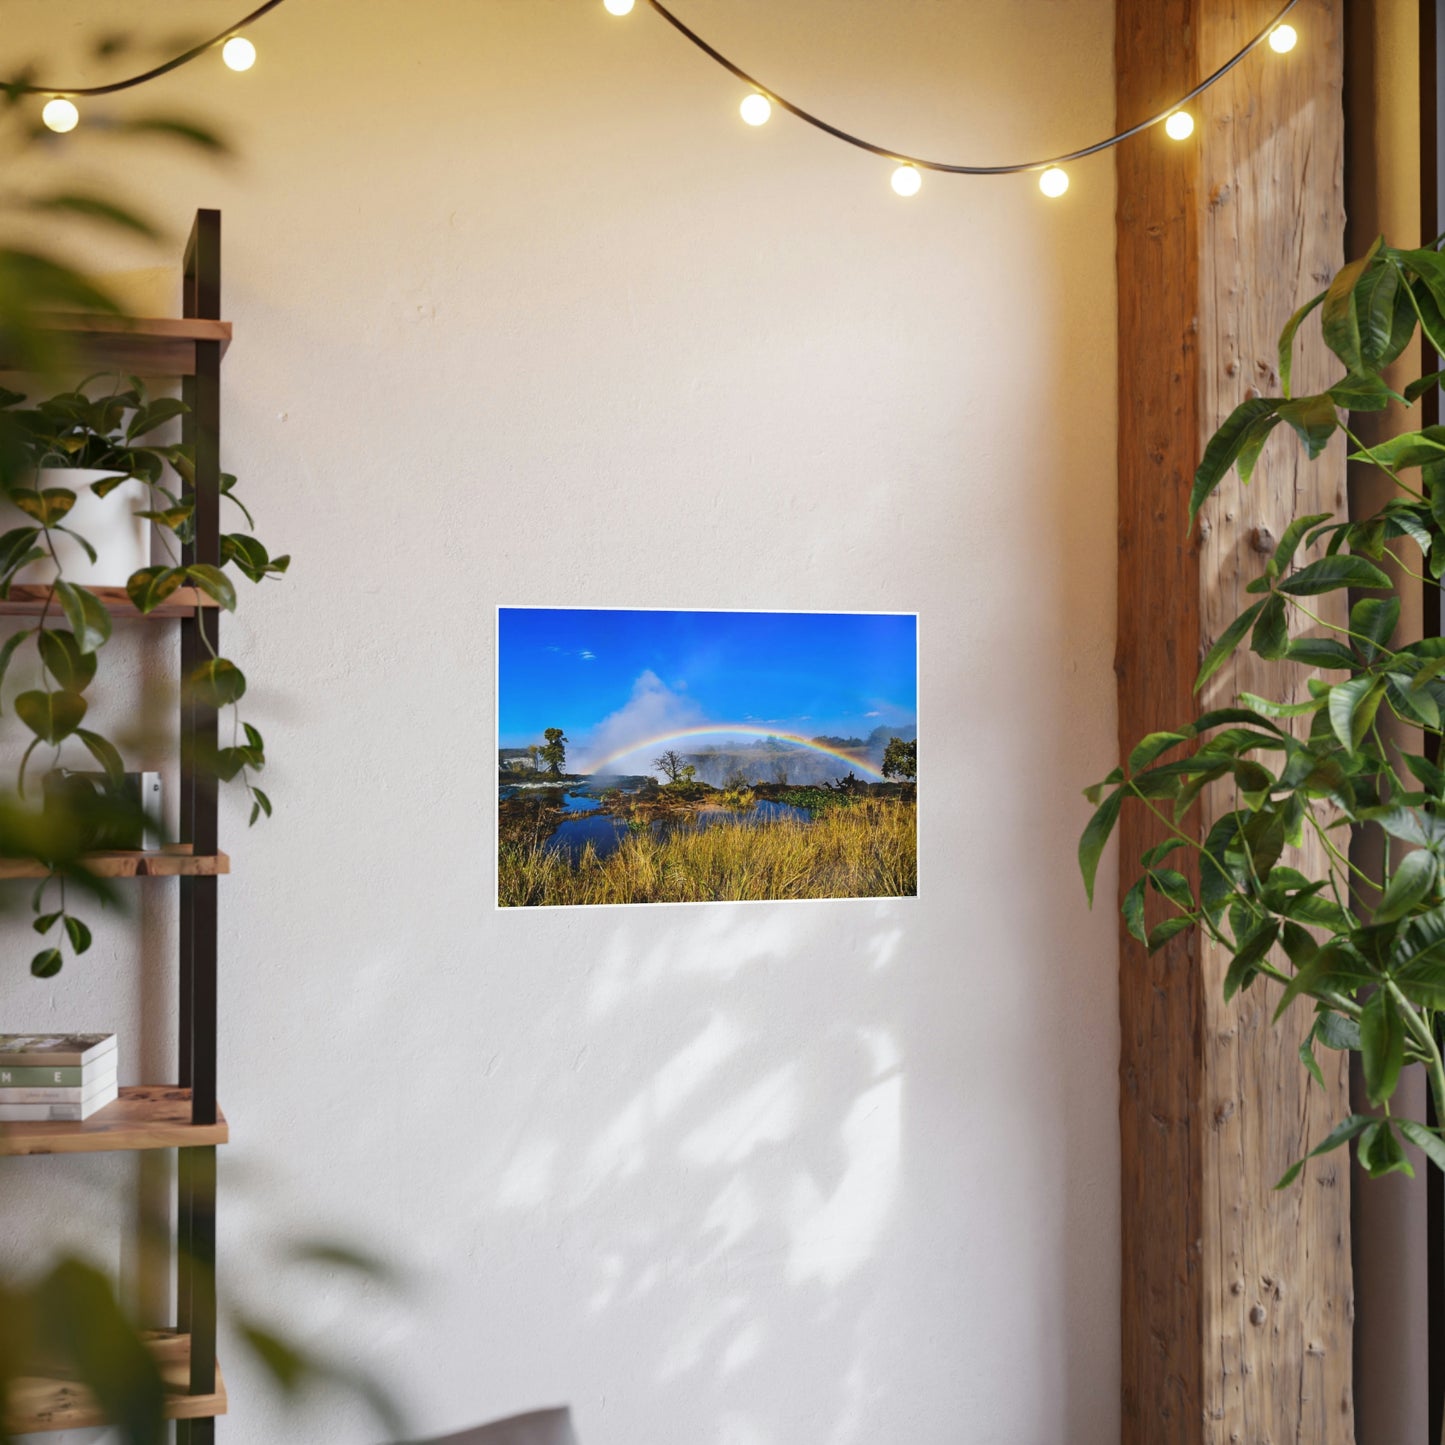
[497,799,918,907]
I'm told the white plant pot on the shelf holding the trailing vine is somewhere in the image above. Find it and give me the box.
[0,467,150,587]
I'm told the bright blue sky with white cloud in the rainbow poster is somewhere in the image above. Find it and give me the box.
[497,607,918,766]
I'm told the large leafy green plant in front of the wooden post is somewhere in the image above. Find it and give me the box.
[1079,238,1445,1188]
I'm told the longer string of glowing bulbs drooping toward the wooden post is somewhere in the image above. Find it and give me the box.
[604,0,1299,195]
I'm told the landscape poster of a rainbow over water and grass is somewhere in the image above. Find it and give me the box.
[497,607,918,907]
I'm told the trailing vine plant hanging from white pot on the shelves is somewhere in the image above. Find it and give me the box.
[0,377,290,978]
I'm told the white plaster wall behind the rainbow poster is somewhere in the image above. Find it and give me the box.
[0,0,1118,1445]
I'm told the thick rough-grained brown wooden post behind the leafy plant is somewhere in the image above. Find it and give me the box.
[1116,0,1354,1445]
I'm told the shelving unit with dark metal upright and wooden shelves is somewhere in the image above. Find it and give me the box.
[0,211,231,1445]
